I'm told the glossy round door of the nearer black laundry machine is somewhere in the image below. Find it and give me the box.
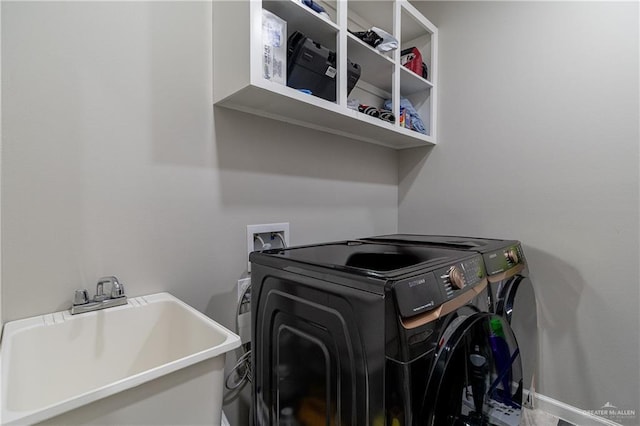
[421,308,522,426]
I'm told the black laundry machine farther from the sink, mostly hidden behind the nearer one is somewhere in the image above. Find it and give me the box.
[365,234,538,407]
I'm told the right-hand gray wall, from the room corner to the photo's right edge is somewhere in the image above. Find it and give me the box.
[398,2,640,418]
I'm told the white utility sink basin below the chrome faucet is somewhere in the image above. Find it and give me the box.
[0,293,240,425]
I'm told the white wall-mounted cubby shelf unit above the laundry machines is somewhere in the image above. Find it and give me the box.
[213,0,438,149]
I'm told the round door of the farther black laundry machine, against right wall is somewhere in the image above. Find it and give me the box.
[496,275,538,405]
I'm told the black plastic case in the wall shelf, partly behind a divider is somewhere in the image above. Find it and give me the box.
[287,31,360,102]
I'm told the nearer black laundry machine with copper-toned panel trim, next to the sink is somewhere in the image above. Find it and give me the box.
[250,241,523,426]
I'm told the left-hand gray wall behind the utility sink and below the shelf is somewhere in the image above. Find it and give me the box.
[2,1,397,420]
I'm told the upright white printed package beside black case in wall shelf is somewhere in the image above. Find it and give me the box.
[262,9,287,85]
